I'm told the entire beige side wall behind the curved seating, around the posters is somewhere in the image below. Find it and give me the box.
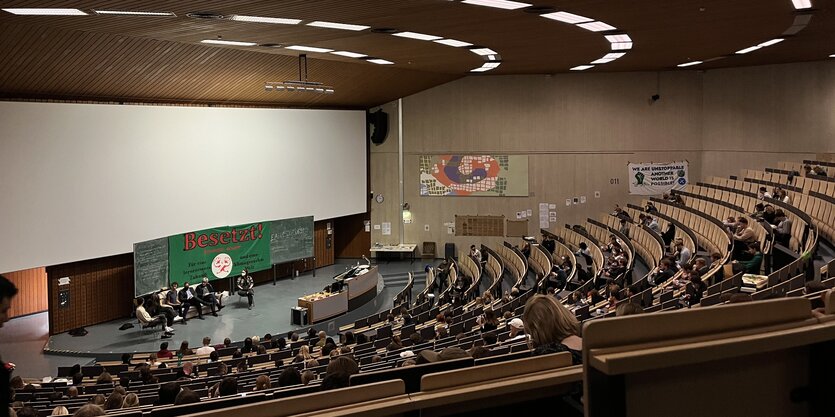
[370,62,835,253]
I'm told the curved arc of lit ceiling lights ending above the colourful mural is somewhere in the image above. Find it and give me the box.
[461,0,634,72]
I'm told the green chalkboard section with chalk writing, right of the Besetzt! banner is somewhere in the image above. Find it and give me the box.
[270,216,313,264]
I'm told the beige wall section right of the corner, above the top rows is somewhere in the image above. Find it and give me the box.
[702,60,835,176]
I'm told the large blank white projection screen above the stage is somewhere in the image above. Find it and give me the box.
[0,102,368,272]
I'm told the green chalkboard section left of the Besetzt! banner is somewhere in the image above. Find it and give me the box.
[133,237,168,296]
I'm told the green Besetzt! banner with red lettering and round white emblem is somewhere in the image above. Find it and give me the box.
[168,222,272,283]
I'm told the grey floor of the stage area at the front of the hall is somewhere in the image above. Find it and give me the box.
[0,260,432,377]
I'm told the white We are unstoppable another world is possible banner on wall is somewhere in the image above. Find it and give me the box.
[629,161,688,195]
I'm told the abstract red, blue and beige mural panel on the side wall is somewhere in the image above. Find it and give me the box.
[419,155,528,197]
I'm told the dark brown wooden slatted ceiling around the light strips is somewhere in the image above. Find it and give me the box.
[0,0,835,108]
